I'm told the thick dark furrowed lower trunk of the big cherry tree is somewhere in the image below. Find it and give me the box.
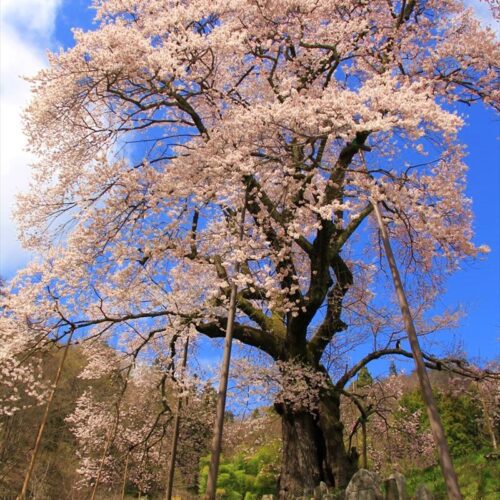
[276,384,357,499]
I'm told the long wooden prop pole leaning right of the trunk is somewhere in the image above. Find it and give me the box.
[372,200,462,500]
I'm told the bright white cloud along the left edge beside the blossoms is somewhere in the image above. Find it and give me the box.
[0,0,61,277]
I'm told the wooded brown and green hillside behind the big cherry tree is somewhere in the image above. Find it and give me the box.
[0,346,500,500]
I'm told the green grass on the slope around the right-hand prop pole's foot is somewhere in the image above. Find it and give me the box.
[406,451,500,500]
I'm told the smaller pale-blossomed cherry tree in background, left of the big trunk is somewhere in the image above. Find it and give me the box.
[66,337,214,494]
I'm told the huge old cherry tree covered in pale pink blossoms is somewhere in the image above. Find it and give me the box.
[0,0,499,498]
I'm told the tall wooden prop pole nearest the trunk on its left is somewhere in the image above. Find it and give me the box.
[205,191,248,500]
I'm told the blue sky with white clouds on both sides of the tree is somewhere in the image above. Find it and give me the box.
[0,0,500,370]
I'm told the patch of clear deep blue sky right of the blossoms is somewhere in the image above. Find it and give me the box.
[442,107,500,358]
